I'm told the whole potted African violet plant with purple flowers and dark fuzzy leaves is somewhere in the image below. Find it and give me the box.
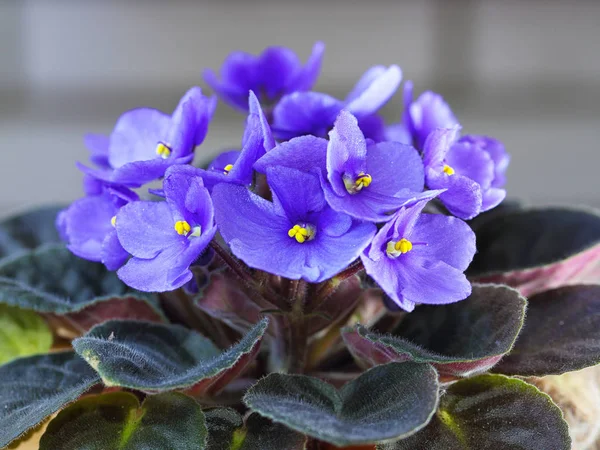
[0,43,600,450]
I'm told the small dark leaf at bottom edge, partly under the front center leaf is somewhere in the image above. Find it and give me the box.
[206,408,306,450]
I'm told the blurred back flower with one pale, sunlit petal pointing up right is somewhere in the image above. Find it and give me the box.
[273,65,402,140]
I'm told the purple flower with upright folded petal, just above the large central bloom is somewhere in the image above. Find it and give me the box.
[255,110,435,222]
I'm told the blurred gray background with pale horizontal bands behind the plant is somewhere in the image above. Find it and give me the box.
[0,0,600,216]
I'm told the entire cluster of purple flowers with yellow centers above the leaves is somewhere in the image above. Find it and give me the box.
[57,43,509,311]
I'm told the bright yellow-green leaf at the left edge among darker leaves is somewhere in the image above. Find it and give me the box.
[0,304,52,364]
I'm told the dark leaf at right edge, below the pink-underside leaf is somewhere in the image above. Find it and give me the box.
[494,285,600,376]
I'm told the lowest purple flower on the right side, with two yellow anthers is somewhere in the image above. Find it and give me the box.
[361,200,475,311]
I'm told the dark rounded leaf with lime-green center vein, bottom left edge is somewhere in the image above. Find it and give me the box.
[40,392,207,450]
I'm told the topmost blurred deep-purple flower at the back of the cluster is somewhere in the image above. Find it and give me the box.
[204,42,325,111]
